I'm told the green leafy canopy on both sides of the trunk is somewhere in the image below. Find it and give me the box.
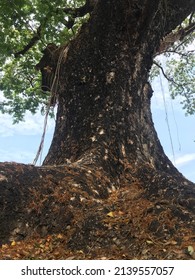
[0,0,195,122]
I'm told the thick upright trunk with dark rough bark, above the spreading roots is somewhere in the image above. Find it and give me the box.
[40,1,191,182]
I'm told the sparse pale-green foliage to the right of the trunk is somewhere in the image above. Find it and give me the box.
[150,14,195,114]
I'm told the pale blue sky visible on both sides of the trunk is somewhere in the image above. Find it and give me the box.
[0,74,195,182]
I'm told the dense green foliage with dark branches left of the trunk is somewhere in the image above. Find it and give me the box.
[0,0,84,122]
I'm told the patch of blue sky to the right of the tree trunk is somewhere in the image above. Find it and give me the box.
[152,76,195,182]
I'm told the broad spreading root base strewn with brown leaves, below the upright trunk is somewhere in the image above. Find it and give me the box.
[0,163,195,259]
